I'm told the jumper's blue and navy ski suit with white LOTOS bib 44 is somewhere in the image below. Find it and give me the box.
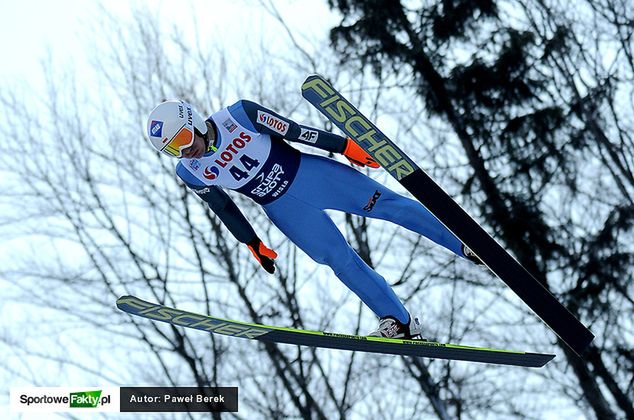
[176,100,464,323]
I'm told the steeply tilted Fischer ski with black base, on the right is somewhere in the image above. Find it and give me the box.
[302,75,594,355]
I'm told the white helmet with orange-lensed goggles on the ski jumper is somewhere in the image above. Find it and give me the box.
[147,100,207,157]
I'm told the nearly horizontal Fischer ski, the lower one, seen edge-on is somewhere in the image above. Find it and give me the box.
[117,296,555,367]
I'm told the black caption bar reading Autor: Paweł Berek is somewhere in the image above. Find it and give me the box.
[120,387,238,413]
